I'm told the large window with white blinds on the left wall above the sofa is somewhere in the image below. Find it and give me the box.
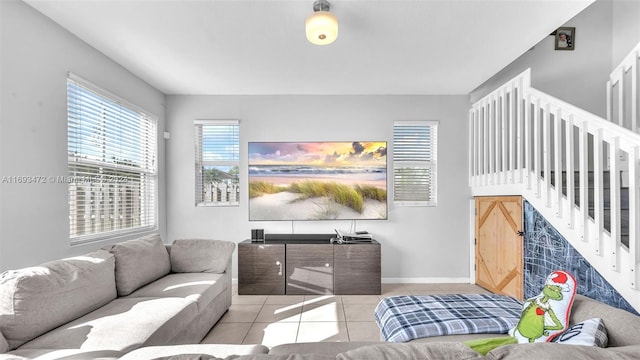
[64,74,158,244]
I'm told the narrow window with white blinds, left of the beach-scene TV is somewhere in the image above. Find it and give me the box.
[195,120,240,206]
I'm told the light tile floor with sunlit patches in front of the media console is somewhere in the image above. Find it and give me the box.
[202,284,488,347]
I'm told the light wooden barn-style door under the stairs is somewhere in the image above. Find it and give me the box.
[476,196,524,300]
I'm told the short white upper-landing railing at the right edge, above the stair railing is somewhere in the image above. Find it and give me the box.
[607,43,640,133]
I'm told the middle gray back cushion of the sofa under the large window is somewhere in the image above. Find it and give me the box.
[106,234,171,296]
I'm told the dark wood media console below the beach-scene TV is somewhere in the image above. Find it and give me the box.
[238,234,381,295]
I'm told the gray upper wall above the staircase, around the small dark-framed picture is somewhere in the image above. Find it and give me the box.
[471,0,616,118]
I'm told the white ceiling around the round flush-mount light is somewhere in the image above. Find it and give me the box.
[24,0,594,95]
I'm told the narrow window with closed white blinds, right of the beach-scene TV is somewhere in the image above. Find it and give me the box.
[393,121,438,206]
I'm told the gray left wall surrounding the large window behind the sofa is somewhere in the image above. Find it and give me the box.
[0,0,166,270]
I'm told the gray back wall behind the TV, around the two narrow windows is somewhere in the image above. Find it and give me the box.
[166,96,470,281]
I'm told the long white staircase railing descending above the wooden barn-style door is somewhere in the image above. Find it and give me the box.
[469,70,640,310]
